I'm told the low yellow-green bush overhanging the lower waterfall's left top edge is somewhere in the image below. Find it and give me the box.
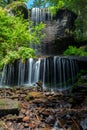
[0,47,35,67]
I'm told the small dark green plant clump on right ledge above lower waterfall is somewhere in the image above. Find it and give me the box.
[63,46,87,56]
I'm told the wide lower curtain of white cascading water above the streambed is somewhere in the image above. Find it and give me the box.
[1,56,78,91]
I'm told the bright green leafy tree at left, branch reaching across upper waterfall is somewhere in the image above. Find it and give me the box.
[0,8,44,68]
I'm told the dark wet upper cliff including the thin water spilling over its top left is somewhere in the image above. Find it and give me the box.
[31,9,77,55]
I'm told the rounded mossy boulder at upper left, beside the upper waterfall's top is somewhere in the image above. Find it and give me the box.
[6,1,28,19]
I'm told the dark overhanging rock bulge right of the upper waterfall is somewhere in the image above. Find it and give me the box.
[44,9,77,43]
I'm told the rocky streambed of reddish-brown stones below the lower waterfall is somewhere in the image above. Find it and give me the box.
[0,87,87,130]
